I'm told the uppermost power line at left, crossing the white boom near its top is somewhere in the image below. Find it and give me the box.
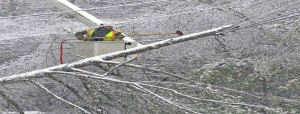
[0,0,168,19]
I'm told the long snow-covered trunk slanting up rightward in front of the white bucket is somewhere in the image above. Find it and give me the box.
[0,25,232,84]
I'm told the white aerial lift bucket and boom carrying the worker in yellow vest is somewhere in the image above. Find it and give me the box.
[47,0,141,63]
